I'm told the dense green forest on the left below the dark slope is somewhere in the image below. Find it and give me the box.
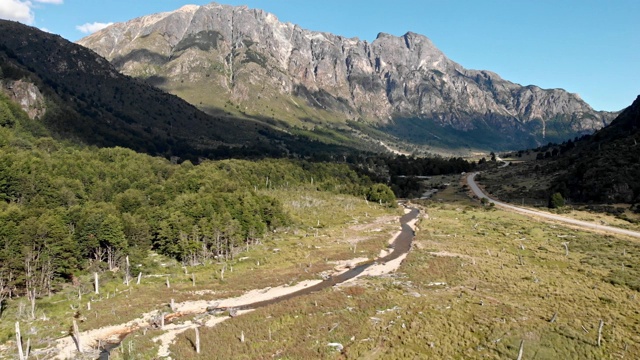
[0,116,395,294]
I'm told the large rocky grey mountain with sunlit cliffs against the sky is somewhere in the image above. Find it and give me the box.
[78,3,613,149]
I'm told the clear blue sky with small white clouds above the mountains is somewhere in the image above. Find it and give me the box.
[0,0,640,110]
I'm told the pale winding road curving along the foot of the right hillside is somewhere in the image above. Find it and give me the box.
[467,172,640,238]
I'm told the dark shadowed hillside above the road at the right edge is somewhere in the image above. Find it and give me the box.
[472,96,640,212]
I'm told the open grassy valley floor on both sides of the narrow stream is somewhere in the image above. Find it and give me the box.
[3,179,640,359]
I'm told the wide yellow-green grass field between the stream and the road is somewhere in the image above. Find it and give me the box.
[171,187,640,359]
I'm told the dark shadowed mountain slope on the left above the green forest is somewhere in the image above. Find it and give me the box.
[0,20,379,160]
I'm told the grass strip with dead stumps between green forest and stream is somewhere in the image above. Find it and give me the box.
[0,189,399,358]
